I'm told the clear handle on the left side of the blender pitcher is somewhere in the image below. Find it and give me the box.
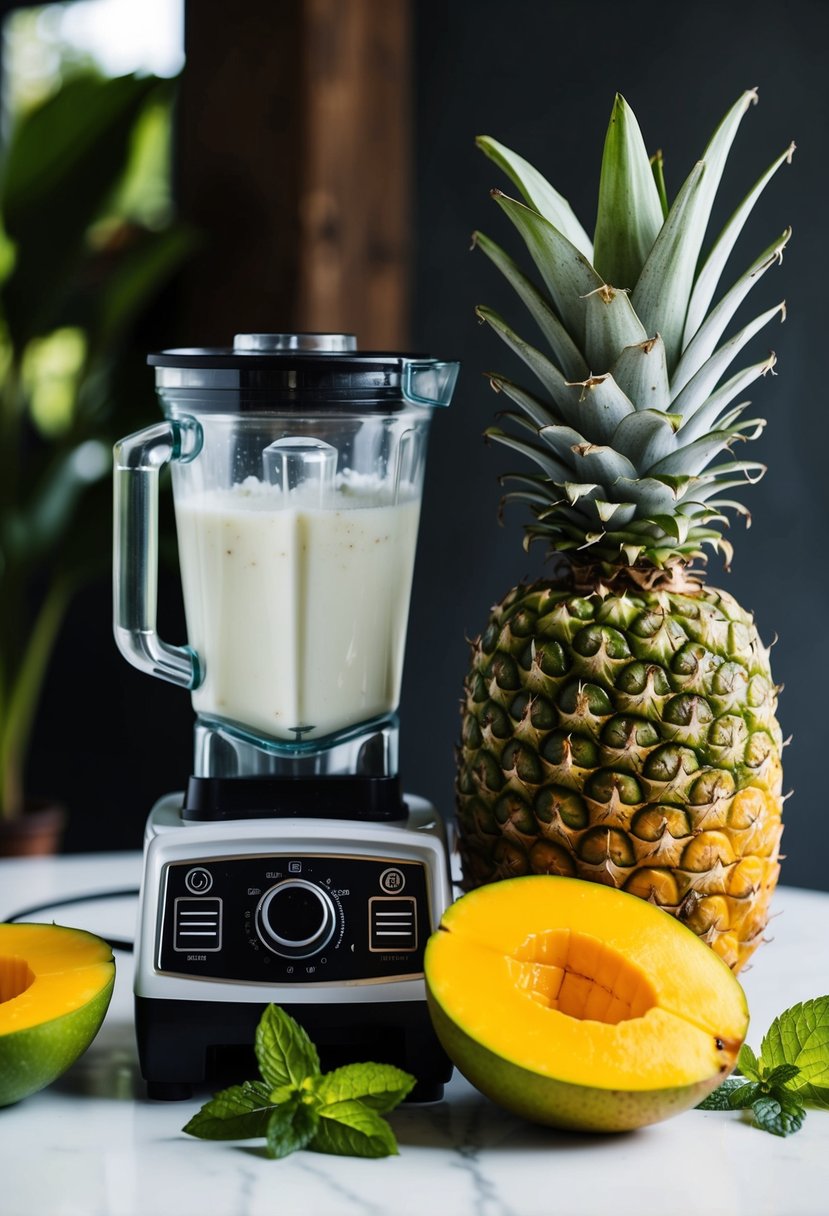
[112,416,203,688]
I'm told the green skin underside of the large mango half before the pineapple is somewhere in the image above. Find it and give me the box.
[427,984,726,1132]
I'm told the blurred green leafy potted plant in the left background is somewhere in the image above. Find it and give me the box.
[0,72,193,854]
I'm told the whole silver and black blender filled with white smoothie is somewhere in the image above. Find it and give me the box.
[113,333,458,1100]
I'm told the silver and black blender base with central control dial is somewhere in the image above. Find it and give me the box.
[135,794,452,1103]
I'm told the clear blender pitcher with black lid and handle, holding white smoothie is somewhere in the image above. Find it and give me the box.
[113,334,458,777]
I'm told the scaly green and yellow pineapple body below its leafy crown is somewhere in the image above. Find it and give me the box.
[456,580,783,973]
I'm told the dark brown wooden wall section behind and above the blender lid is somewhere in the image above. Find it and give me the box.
[175,0,412,349]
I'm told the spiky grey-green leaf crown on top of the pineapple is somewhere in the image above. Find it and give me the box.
[473,89,795,584]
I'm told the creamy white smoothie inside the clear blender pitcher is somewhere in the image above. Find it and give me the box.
[175,478,419,741]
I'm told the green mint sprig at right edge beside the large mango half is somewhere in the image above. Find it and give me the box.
[697,996,829,1136]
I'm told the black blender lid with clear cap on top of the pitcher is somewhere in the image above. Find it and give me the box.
[147,333,459,407]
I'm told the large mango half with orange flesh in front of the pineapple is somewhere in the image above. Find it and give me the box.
[424,874,749,1132]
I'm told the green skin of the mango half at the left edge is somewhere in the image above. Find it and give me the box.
[0,966,115,1107]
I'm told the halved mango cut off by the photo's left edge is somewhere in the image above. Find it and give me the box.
[0,923,115,1107]
